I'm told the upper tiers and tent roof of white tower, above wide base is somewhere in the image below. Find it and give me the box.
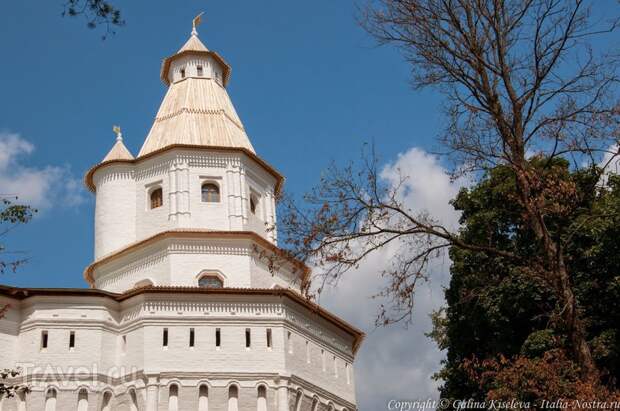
[85,24,288,292]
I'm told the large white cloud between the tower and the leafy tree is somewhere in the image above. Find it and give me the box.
[320,148,467,411]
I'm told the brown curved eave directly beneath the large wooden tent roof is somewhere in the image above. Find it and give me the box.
[84,144,284,198]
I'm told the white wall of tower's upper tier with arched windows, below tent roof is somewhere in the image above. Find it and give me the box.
[93,149,276,259]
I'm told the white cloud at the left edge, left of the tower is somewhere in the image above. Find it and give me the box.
[0,132,85,211]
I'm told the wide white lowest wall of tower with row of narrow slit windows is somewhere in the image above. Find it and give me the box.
[0,294,354,411]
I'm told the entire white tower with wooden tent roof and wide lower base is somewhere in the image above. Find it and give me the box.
[0,20,363,411]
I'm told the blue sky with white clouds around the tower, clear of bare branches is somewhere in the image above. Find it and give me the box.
[0,0,618,411]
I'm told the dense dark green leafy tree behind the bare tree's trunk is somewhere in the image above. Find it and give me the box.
[432,158,620,400]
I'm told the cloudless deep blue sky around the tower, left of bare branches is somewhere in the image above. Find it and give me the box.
[0,0,439,287]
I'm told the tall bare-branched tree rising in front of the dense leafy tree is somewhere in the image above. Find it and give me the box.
[281,0,620,384]
